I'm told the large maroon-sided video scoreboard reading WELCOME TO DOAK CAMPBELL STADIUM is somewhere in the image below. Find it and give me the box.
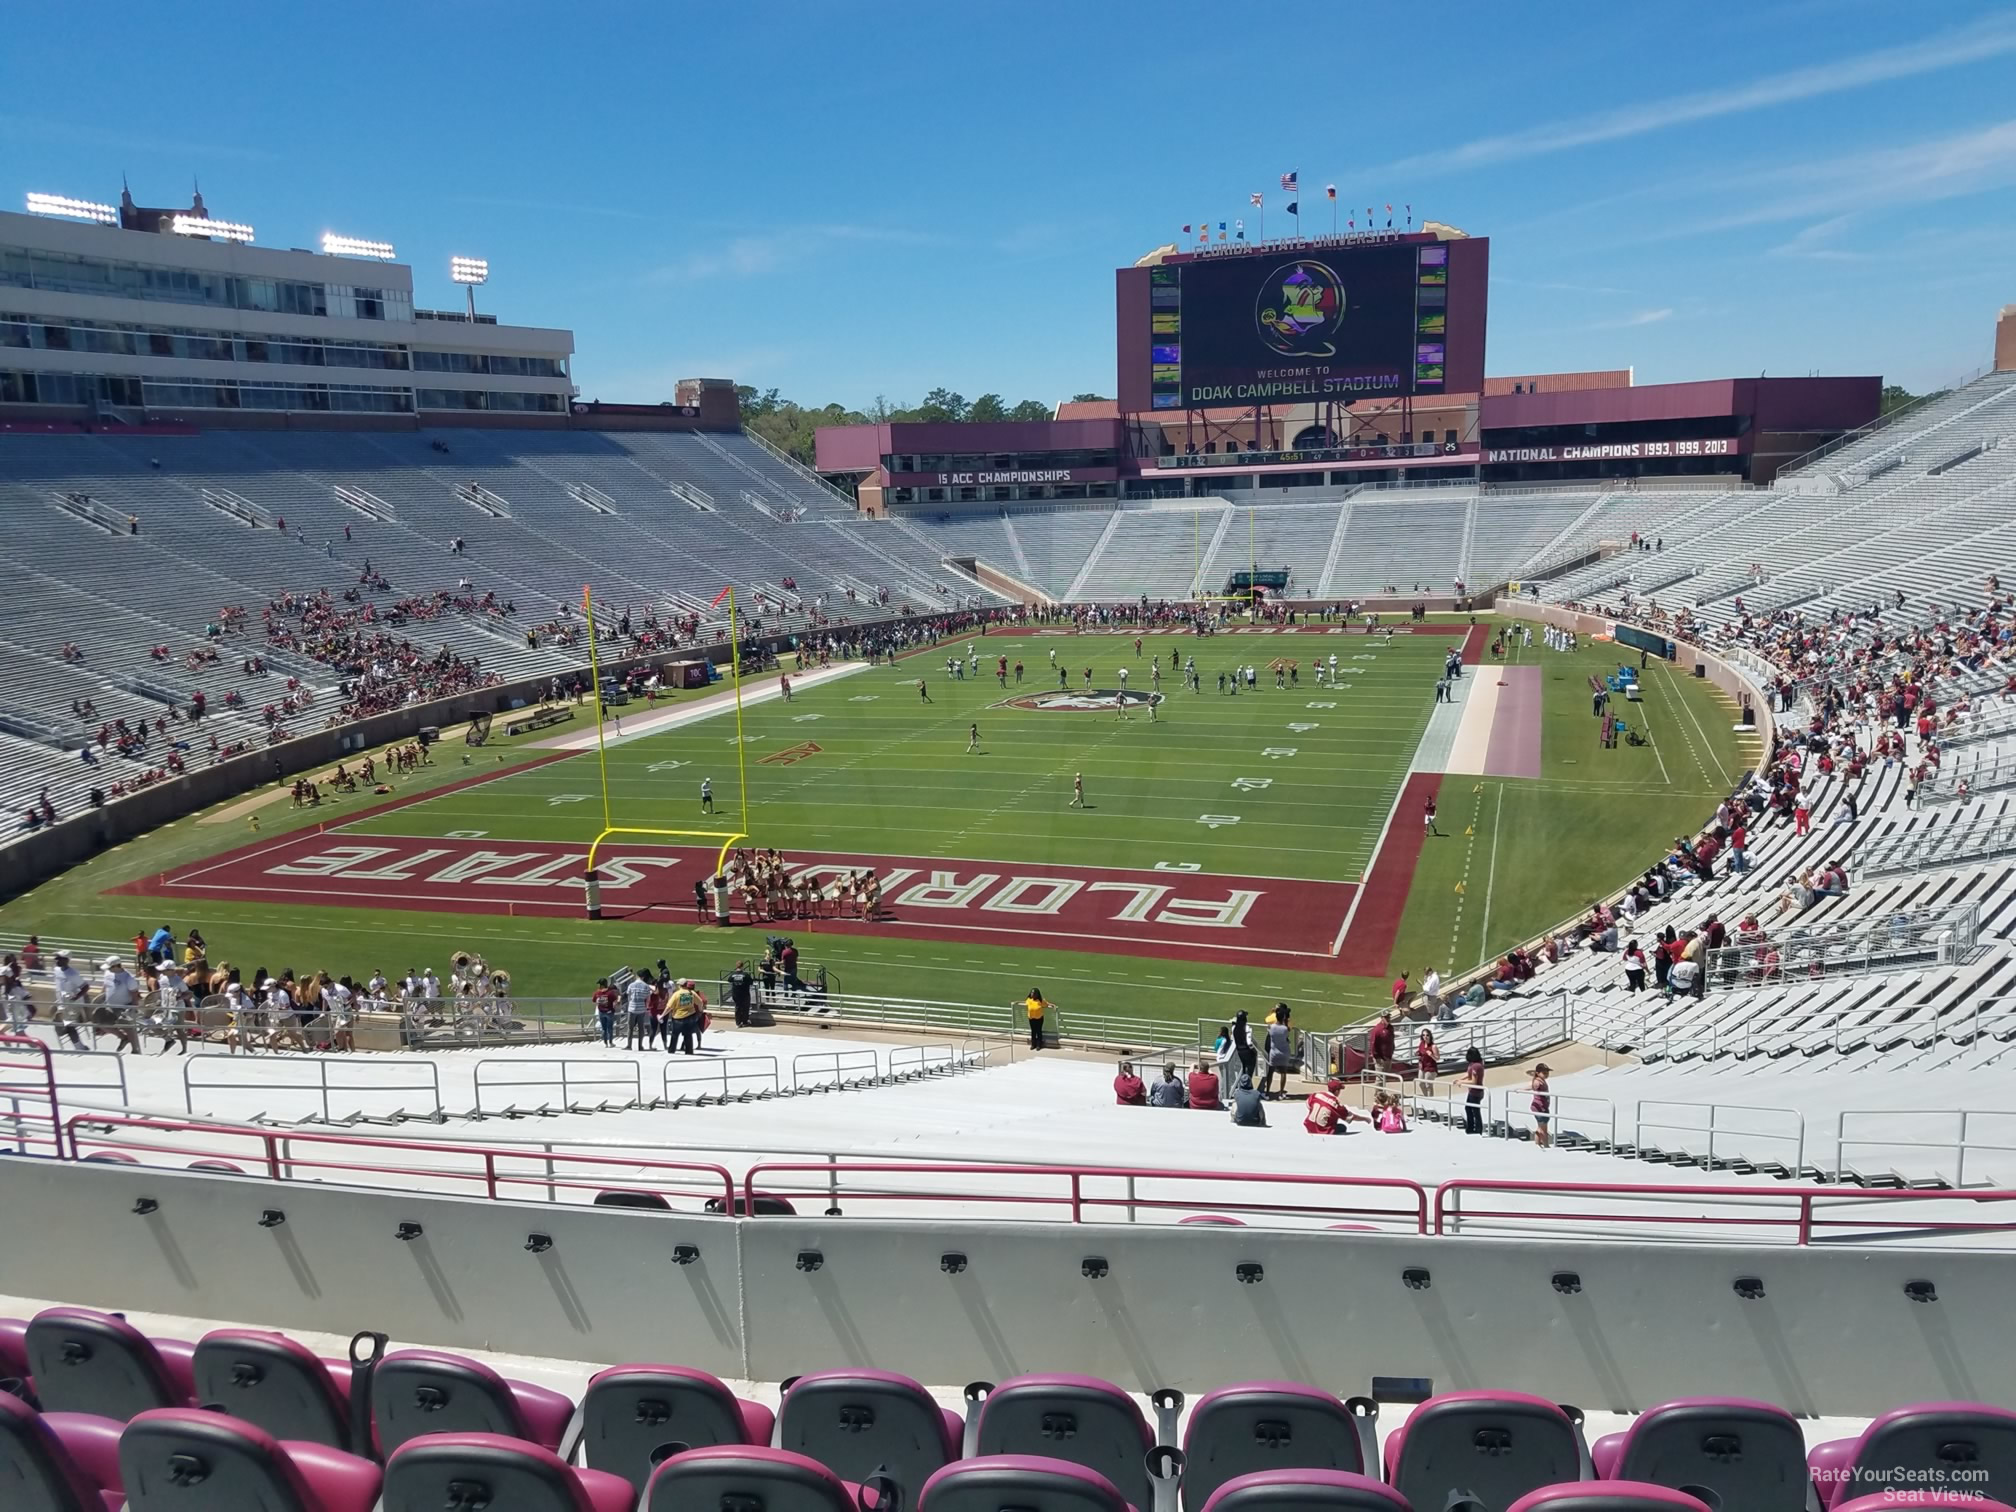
[1117,236,1488,413]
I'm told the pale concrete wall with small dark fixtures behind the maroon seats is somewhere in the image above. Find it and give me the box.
[0,1157,2016,1415]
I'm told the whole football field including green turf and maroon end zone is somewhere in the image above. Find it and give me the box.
[23,623,1744,1022]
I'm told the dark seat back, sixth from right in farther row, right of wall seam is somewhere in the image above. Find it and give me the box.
[776,1371,960,1506]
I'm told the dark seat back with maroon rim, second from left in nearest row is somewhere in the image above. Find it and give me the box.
[119,1407,321,1512]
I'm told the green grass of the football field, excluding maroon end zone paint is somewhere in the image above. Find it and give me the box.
[0,625,1754,1024]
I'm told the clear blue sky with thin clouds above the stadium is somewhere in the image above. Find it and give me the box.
[0,0,2016,405]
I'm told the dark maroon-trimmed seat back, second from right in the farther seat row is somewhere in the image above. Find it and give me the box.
[1605,1397,1812,1512]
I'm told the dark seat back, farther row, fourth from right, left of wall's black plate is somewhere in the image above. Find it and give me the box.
[1183,1381,1365,1512]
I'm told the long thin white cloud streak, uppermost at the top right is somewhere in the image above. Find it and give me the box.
[1375,14,2016,175]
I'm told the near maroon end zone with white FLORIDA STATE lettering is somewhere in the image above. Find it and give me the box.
[113,833,1357,972]
